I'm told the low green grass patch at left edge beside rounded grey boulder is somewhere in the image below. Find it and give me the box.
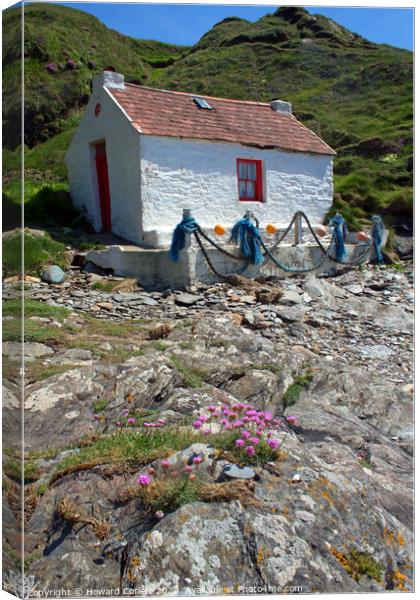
[3,231,66,276]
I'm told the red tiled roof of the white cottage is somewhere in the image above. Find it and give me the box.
[108,83,335,155]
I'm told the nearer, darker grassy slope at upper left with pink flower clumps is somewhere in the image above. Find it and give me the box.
[3,4,187,148]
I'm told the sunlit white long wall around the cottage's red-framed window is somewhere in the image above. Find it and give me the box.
[140,135,333,246]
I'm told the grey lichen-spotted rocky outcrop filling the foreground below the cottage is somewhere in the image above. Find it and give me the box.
[0,268,413,595]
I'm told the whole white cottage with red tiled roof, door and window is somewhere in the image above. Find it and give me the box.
[66,70,335,248]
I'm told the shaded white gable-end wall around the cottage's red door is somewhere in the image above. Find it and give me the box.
[66,82,142,243]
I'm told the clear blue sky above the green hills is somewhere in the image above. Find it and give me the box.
[58,2,414,50]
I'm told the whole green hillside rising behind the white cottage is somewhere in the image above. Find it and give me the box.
[3,4,413,232]
